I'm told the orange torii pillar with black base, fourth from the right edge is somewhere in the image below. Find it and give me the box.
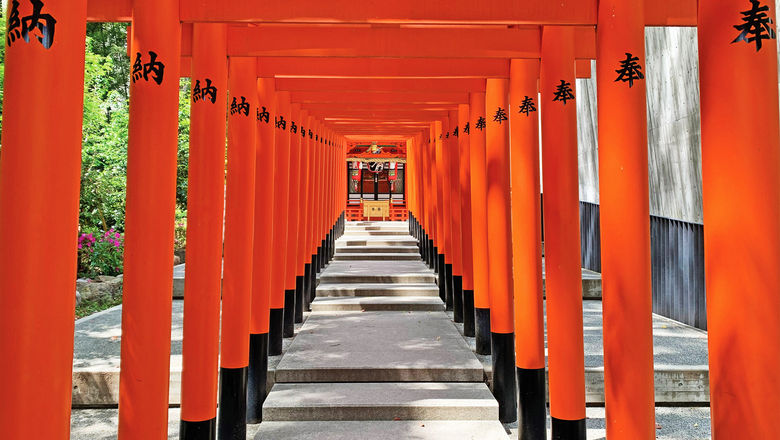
[509,60,547,440]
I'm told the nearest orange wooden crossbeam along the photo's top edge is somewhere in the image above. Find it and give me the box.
[87,0,697,26]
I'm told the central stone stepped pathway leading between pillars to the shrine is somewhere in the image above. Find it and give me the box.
[258,223,507,440]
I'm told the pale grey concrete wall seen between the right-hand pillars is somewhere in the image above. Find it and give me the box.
[577,27,702,222]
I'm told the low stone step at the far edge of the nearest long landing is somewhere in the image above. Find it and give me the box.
[311,296,444,312]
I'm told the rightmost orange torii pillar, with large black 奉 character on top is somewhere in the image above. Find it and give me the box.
[699,0,780,439]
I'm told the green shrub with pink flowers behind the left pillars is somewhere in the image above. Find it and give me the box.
[79,228,124,278]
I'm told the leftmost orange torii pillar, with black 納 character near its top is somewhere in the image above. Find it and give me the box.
[0,0,87,439]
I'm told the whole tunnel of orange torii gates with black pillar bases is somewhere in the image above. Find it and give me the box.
[0,0,780,440]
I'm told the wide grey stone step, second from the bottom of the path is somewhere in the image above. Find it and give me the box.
[263,382,498,422]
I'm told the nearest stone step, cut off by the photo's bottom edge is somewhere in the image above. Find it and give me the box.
[257,420,508,440]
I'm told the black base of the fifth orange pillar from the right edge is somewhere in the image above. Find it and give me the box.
[491,333,517,423]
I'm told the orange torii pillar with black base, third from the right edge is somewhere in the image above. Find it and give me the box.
[540,26,585,440]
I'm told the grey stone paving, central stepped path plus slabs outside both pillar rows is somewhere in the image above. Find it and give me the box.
[68,222,709,440]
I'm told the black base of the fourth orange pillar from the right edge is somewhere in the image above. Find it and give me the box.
[517,367,547,440]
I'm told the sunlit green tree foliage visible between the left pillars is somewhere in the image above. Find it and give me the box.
[0,21,190,232]
